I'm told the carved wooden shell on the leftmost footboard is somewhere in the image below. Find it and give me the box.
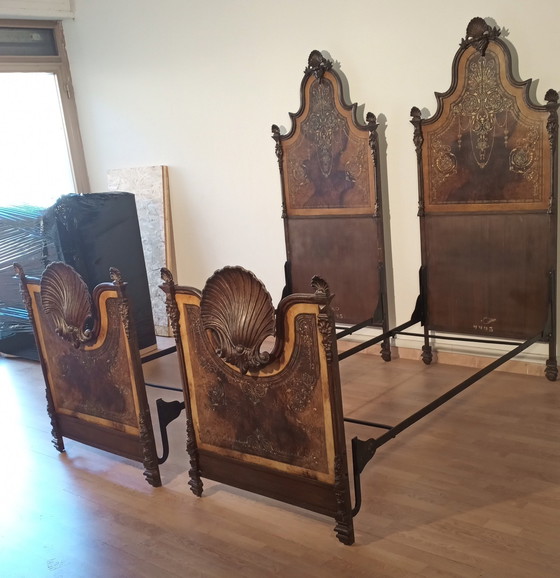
[41,262,92,348]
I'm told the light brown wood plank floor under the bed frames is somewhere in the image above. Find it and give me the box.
[0,346,560,578]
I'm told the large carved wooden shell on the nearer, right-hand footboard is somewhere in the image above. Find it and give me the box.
[200,267,275,374]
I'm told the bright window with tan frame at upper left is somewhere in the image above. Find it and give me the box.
[0,21,89,206]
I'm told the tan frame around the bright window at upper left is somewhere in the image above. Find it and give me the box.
[0,19,90,194]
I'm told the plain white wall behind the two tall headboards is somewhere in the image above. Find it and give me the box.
[60,0,560,360]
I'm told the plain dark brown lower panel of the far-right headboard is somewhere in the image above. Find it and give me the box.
[425,213,551,339]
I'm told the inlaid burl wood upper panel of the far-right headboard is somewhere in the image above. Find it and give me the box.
[423,42,551,212]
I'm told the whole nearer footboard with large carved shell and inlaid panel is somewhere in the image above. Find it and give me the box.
[161,267,354,544]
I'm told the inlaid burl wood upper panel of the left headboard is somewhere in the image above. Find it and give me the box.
[282,71,376,216]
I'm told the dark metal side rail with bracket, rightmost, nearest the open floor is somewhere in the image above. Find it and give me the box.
[347,333,543,516]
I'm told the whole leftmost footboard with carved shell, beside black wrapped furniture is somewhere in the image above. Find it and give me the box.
[14,262,161,486]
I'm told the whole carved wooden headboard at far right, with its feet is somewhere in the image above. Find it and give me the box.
[411,18,558,380]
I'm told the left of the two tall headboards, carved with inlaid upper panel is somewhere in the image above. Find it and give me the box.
[272,50,387,338]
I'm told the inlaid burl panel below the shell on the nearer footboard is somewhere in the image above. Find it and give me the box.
[184,305,334,474]
